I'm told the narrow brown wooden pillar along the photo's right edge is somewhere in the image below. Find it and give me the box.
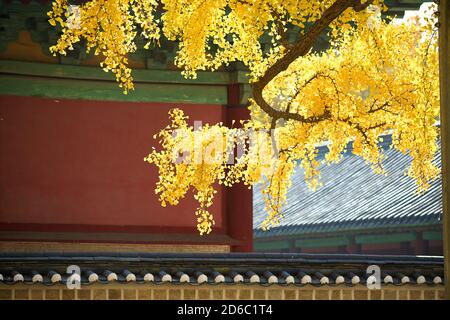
[439,0,450,300]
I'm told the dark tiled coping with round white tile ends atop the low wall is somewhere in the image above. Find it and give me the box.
[0,253,443,286]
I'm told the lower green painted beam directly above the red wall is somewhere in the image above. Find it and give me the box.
[0,74,228,105]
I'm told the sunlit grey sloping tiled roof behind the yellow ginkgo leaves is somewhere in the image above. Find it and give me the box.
[253,135,442,238]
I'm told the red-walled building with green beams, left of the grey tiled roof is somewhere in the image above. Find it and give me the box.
[0,1,252,252]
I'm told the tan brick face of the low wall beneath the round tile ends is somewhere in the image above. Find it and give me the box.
[0,284,444,300]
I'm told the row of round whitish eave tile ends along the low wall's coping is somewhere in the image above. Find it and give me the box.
[0,270,443,286]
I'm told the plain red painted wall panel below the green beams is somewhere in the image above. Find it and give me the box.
[0,96,226,233]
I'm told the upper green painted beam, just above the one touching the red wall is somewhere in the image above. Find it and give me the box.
[0,60,248,85]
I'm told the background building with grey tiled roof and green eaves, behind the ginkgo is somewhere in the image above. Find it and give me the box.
[253,135,443,255]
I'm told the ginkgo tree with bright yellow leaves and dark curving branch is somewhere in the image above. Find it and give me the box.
[48,0,439,234]
